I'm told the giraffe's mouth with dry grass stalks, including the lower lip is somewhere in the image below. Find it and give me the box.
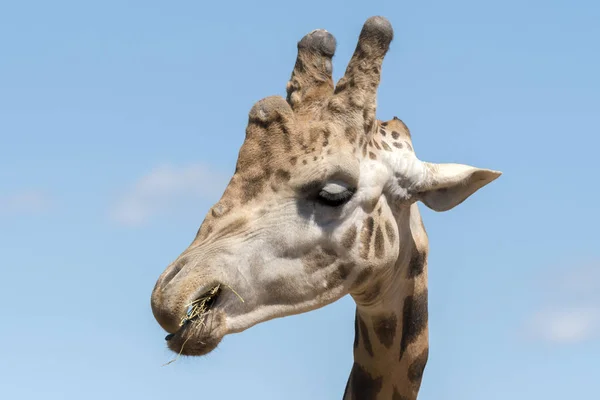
[165,284,224,356]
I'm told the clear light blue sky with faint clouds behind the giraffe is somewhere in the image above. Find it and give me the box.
[0,0,600,400]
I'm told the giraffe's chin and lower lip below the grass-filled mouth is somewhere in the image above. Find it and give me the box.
[166,310,225,356]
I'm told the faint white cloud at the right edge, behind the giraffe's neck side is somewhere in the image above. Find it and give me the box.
[528,264,600,344]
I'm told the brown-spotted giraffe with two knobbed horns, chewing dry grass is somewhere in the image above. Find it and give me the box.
[151,16,501,400]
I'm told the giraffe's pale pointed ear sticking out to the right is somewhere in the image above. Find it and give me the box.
[417,163,502,211]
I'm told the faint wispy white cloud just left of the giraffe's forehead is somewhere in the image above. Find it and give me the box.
[111,164,227,226]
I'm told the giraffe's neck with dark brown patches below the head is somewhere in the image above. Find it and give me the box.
[344,204,429,400]
